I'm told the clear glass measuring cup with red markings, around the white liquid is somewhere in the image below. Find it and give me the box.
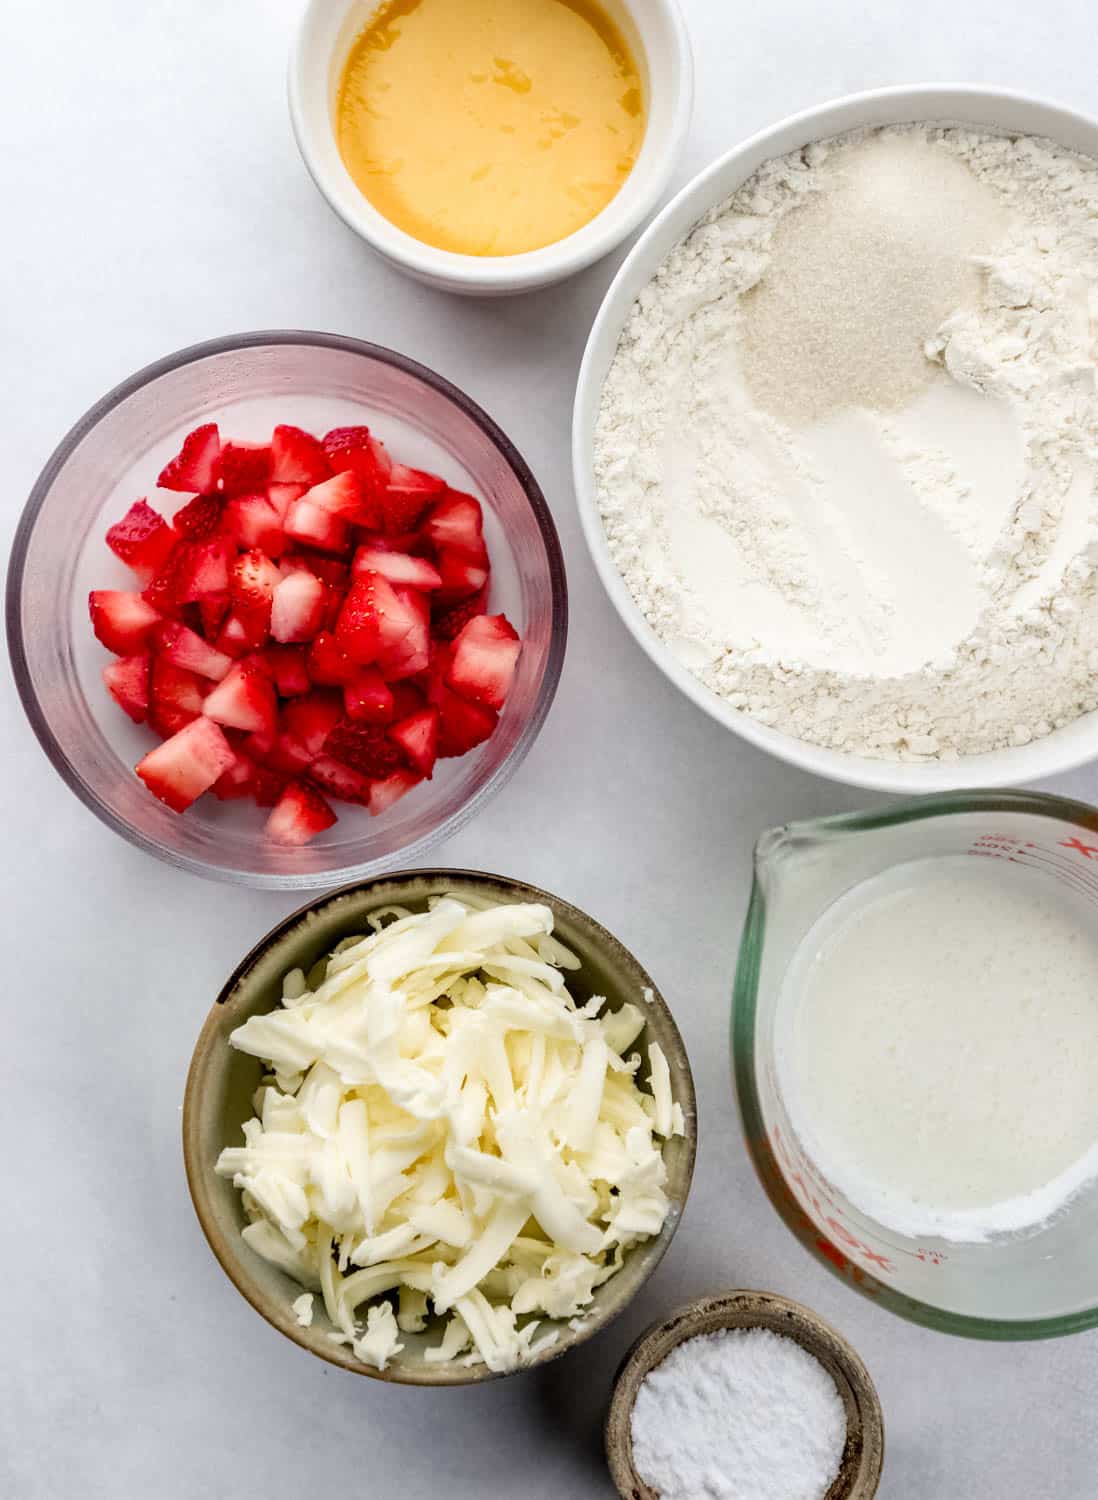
[732,792,1098,1340]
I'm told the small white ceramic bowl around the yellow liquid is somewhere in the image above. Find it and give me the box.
[290,0,693,297]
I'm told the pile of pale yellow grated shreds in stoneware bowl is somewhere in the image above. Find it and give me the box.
[216,896,684,1370]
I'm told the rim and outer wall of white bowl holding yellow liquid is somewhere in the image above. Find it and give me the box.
[288,0,695,294]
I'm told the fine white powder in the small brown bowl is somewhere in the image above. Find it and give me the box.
[632,1328,846,1500]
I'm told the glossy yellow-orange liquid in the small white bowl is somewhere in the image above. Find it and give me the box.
[336,0,645,255]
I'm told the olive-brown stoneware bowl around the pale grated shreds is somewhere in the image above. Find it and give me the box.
[183,870,698,1386]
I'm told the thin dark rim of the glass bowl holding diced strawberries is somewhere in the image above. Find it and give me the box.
[5,329,569,891]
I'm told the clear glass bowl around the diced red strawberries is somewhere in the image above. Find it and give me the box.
[8,332,567,890]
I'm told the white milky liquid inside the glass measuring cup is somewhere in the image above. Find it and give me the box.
[777,855,1098,1241]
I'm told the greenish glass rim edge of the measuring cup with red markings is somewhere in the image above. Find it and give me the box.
[729,791,1098,1343]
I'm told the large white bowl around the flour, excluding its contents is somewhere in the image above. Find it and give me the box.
[572,84,1098,795]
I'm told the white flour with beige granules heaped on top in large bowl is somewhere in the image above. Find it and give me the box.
[596,126,1098,759]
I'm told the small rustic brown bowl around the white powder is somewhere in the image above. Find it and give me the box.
[606,1292,885,1500]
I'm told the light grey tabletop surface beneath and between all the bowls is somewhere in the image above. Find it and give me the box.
[0,0,1098,1500]
